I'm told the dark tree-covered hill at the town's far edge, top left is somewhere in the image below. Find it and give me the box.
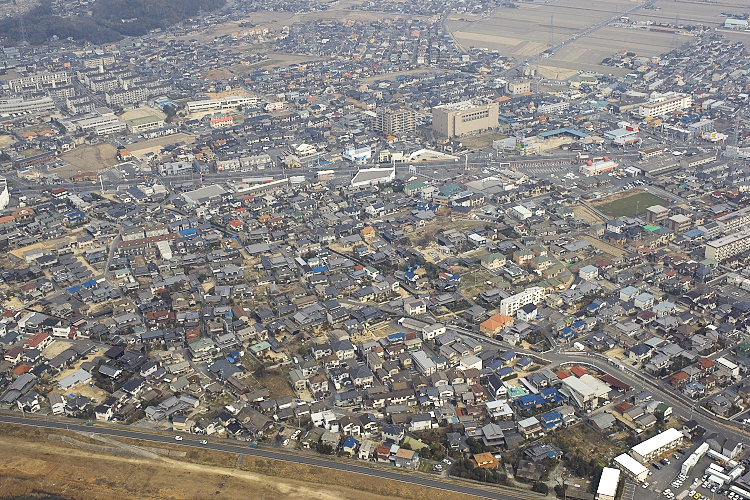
[0,0,226,45]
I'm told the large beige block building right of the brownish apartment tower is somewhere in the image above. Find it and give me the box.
[432,101,499,137]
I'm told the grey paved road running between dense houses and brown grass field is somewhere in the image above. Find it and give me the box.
[0,415,541,500]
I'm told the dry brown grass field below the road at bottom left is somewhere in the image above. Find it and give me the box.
[0,424,488,500]
